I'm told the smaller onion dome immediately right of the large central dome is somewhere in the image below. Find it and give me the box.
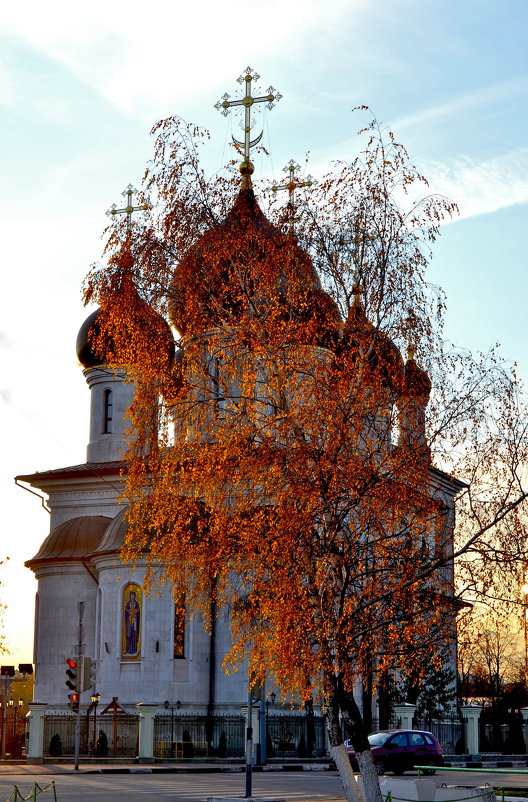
[340,298,403,394]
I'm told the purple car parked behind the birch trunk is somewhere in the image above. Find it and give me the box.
[345,730,444,774]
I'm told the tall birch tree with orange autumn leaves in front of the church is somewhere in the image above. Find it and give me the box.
[85,108,527,802]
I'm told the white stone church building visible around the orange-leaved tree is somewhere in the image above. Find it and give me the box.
[17,67,462,761]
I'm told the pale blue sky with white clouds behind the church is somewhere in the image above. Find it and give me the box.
[0,0,528,662]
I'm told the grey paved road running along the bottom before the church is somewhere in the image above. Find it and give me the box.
[0,767,528,802]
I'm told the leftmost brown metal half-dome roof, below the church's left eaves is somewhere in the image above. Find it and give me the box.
[25,515,112,568]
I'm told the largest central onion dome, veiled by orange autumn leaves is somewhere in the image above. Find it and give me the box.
[169,188,341,344]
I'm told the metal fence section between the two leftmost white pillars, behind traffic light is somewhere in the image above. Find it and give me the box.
[43,713,139,757]
